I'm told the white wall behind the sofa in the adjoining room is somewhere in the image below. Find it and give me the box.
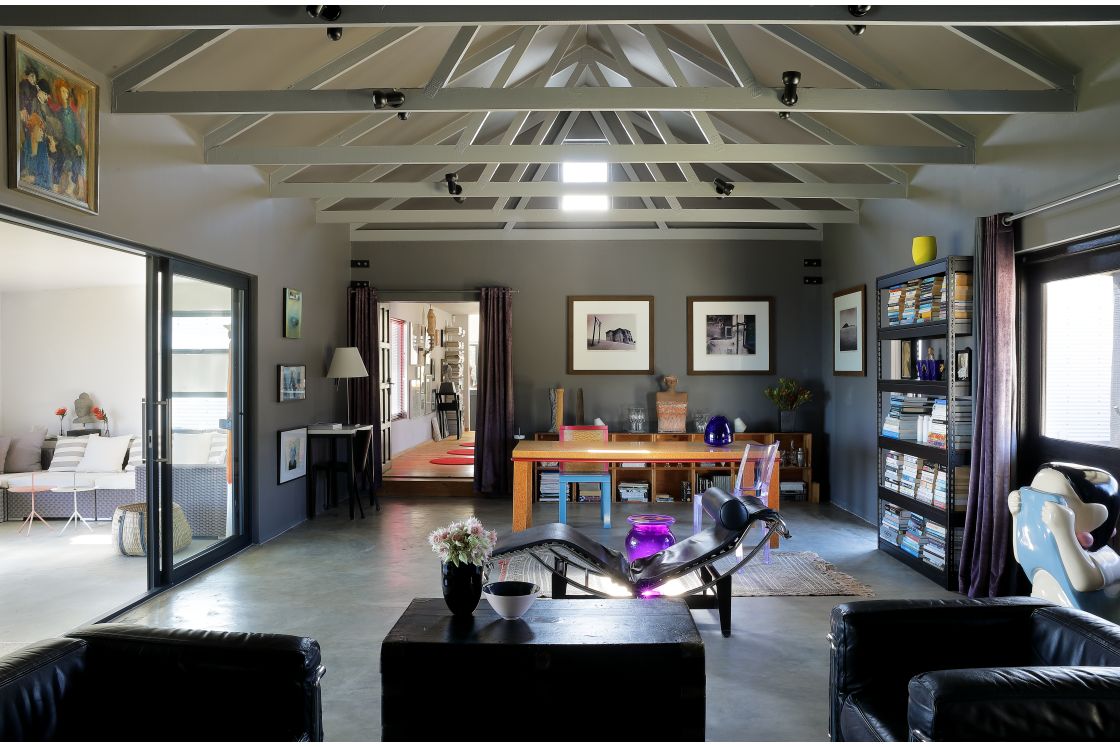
[0,284,144,436]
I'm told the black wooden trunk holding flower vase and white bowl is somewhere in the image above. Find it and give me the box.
[381,599,706,741]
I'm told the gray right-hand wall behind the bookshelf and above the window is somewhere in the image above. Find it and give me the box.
[820,55,1120,521]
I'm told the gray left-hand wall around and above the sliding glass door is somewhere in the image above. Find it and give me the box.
[0,34,349,540]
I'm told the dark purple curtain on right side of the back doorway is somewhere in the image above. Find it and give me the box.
[475,288,513,496]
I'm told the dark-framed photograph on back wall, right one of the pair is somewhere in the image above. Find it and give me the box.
[687,296,775,376]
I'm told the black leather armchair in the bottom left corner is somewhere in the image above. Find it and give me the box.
[0,625,324,743]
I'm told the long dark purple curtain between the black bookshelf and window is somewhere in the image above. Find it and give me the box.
[959,215,1019,597]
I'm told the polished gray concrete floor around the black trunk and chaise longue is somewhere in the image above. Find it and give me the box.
[109,497,953,741]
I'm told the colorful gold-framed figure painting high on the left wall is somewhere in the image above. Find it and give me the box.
[8,36,100,214]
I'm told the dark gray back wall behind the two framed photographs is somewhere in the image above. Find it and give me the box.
[353,241,823,463]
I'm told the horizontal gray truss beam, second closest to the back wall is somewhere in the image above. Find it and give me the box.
[315,207,859,225]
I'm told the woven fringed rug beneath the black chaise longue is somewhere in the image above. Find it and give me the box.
[491,551,872,597]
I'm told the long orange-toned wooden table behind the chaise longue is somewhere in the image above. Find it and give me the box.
[513,441,778,537]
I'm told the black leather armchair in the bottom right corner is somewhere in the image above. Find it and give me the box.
[829,597,1120,741]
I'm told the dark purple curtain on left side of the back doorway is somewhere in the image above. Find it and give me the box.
[346,288,381,488]
